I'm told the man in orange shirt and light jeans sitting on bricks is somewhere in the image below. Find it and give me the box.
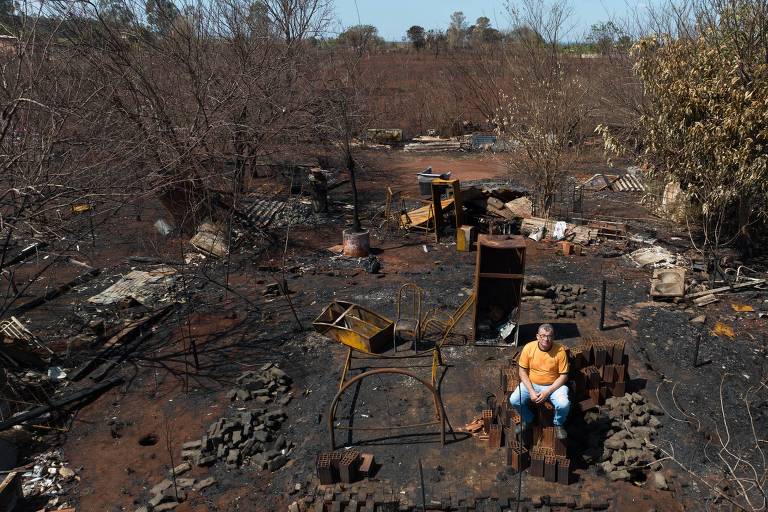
[509,324,571,439]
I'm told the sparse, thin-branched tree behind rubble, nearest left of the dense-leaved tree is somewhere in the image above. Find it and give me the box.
[494,0,590,215]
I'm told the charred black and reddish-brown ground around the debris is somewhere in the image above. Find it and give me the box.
[3,153,768,511]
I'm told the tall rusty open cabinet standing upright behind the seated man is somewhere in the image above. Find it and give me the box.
[472,235,525,344]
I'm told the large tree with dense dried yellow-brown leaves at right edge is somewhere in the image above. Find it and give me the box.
[599,0,768,258]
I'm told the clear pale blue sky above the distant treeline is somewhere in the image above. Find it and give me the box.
[335,0,657,41]
